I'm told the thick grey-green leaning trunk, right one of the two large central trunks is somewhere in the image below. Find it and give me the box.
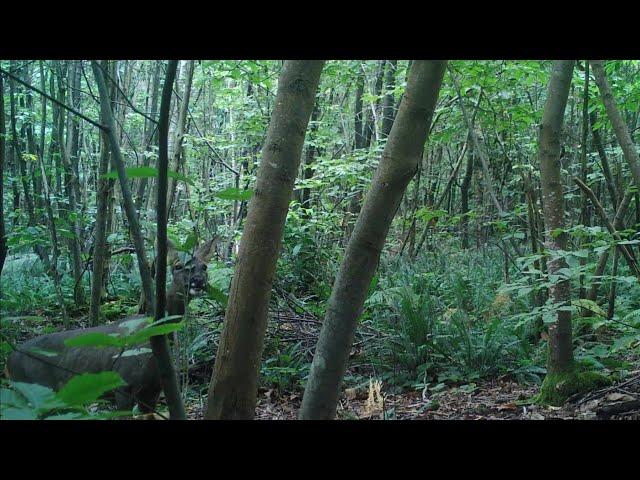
[300,60,447,419]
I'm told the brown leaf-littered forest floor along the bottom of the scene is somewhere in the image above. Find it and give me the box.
[181,370,640,420]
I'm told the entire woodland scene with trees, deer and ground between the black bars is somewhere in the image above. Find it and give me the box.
[0,59,640,420]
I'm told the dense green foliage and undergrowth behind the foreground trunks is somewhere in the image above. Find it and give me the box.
[0,60,640,418]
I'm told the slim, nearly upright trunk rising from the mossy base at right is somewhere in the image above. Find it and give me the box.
[540,60,574,374]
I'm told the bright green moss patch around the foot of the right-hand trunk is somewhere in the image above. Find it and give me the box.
[534,368,611,407]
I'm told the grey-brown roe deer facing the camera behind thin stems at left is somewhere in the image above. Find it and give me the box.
[7,239,215,413]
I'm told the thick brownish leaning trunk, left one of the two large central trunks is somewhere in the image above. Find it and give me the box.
[205,60,324,419]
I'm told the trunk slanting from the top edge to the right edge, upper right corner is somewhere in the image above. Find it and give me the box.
[590,60,640,188]
